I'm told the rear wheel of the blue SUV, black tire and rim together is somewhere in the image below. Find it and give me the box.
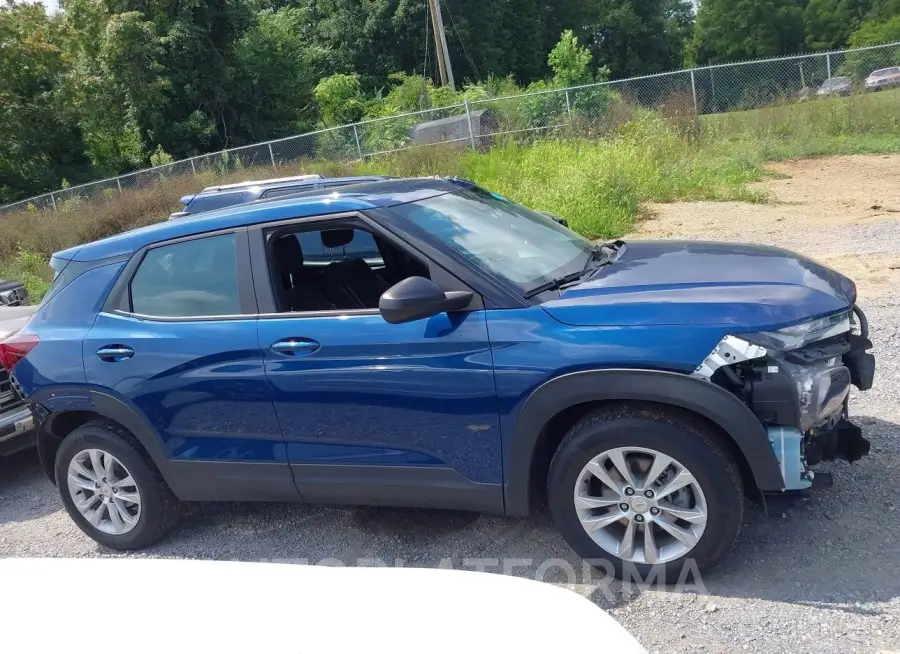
[54,421,178,550]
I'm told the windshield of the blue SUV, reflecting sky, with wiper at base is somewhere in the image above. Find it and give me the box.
[394,187,591,291]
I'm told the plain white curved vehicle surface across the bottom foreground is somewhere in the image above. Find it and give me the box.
[0,559,646,654]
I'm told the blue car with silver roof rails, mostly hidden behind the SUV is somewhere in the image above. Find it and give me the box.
[169,175,386,220]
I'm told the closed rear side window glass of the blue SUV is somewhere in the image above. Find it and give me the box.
[129,234,241,318]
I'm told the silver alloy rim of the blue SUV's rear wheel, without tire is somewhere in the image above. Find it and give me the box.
[67,449,141,535]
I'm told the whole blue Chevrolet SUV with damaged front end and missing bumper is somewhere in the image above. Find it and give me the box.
[0,179,874,579]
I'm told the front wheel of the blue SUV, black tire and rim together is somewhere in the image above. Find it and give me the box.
[547,405,744,583]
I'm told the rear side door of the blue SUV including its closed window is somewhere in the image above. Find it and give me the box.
[83,230,296,499]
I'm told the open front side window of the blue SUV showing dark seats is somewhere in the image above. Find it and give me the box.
[269,227,429,312]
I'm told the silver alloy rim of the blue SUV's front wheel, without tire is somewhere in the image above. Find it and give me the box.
[574,447,707,565]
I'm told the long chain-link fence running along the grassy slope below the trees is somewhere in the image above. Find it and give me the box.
[0,42,900,214]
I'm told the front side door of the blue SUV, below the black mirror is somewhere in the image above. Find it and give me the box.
[251,216,503,512]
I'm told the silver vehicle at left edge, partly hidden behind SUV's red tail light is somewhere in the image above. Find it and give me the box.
[0,306,36,456]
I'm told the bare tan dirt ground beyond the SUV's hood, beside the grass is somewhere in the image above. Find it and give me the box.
[632,154,900,298]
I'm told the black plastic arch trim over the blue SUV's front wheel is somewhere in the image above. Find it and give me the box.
[504,369,784,516]
